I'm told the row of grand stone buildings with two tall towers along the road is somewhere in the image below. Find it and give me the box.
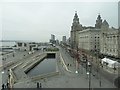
[70,12,120,58]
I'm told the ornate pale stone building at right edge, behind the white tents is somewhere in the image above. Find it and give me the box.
[100,20,120,57]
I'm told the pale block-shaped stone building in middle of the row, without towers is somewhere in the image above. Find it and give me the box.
[78,29,100,51]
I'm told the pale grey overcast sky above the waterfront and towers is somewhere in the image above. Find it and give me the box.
[0,0,118,42]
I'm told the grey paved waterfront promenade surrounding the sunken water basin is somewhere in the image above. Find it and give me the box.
[1,47,118,88]
